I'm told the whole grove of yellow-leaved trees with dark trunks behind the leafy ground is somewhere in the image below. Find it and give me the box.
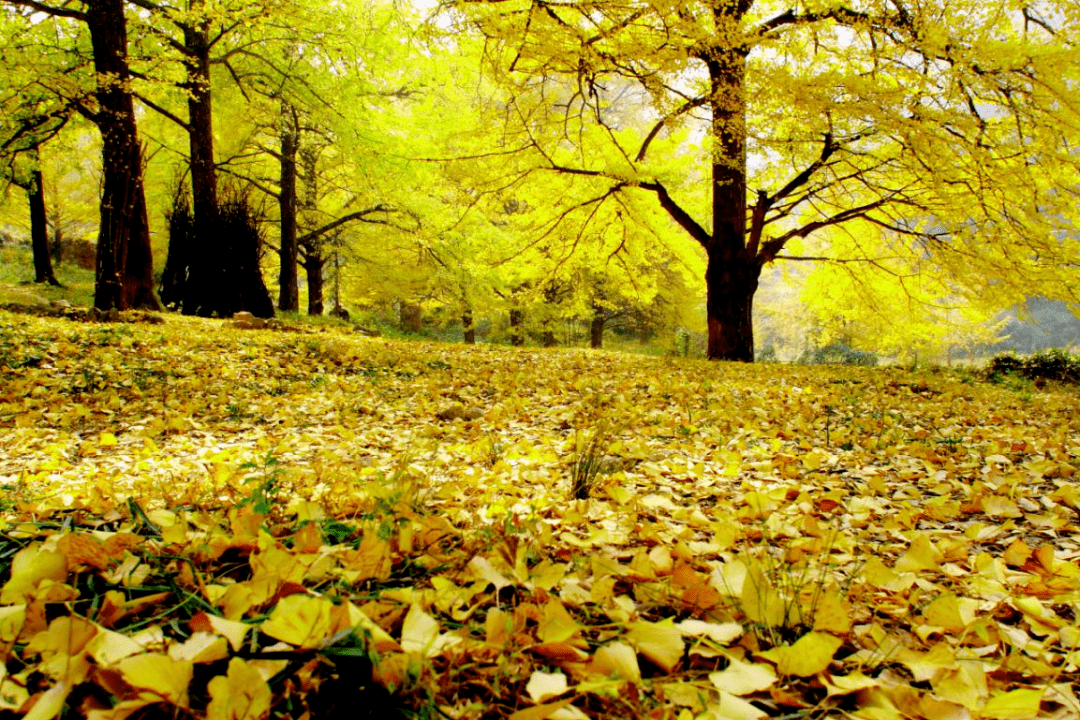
[0,0,1080,361]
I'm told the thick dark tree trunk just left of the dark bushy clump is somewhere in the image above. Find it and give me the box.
[85,0,161,310]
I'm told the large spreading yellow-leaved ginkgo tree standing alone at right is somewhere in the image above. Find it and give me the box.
[454,0,1080,361]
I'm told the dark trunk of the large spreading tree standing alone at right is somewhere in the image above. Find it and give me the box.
[704,40,761,363]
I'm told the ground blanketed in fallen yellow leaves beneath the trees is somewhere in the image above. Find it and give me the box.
[0,313,1080,720]
